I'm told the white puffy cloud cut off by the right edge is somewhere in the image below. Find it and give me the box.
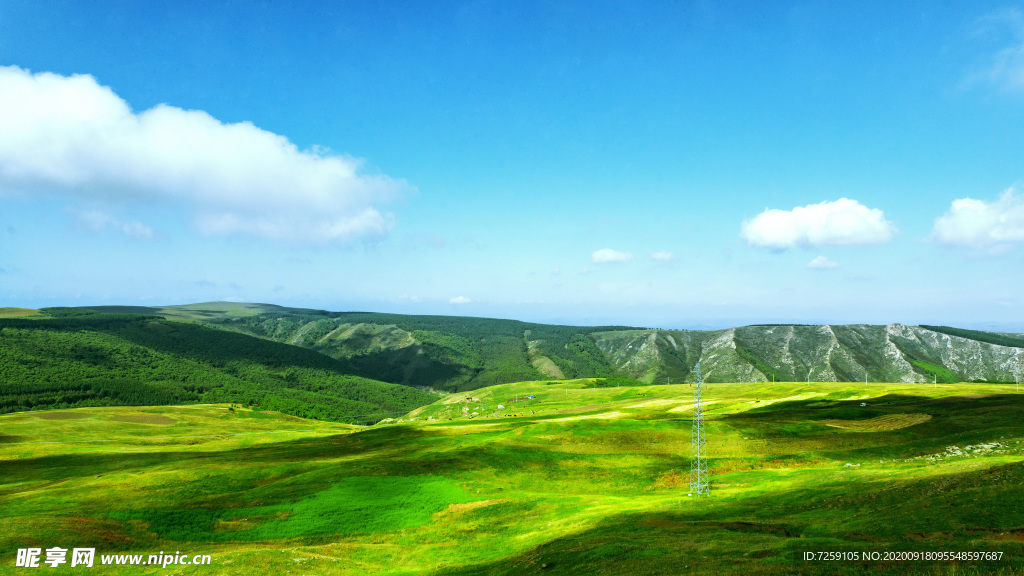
[931,189,1024,251]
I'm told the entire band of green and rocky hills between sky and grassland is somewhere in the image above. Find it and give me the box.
[0,302,1024,422]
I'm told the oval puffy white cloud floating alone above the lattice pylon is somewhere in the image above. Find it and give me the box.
[739,198,896,250]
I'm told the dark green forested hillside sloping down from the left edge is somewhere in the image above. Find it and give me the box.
[0,308,432,422]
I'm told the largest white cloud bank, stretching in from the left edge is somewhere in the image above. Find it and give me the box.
[0,67,411,243]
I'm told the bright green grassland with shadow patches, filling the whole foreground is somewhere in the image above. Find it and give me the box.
[0,378,1024,576]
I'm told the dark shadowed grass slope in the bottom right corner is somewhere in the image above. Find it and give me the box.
[432,462,1024,576]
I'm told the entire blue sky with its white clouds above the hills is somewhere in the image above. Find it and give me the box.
[0,0,1024,331]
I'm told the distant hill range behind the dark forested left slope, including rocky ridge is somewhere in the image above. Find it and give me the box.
[136,304,1024,392]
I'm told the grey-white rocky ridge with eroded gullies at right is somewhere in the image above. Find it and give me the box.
[591,324,1024,382]
